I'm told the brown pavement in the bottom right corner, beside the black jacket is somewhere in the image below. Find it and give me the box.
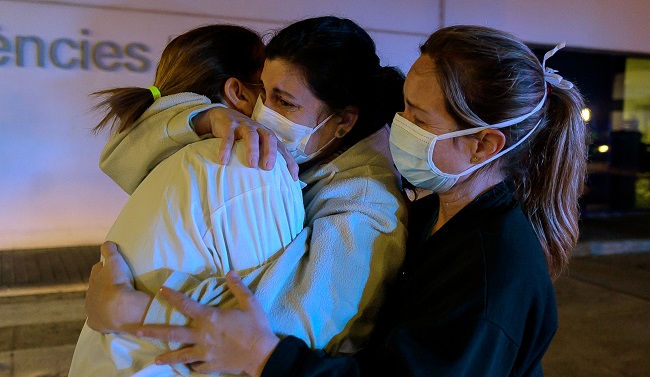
[543,253,650,377]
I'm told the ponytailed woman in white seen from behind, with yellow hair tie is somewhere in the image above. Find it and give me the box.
[69,25,304,377]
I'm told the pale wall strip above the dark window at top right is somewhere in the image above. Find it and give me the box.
[444,0,650,54]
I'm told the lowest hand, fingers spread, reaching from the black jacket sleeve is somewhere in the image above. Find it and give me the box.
[136,271,280,376]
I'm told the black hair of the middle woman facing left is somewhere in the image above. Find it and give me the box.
[266,16,404,146]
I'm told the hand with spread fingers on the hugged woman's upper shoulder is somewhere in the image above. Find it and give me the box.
[192,107,298,180]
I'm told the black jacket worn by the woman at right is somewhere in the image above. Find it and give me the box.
[262,182,557,377]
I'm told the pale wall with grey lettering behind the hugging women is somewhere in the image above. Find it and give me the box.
[0,0,438,249]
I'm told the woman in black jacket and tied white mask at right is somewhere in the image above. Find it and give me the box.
[132,26,588,376]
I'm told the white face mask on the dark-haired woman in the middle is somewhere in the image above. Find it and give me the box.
[251,96,335,164]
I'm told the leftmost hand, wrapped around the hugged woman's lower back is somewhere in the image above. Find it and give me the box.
[86,241,151,333]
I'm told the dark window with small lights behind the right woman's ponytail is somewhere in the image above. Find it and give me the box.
[533,46,650,217]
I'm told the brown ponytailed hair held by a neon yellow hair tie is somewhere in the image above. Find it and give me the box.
[92,25,264,133]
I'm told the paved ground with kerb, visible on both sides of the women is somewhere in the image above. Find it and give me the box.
[0,214,650,377]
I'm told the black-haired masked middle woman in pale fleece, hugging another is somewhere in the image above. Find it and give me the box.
[81,17,406,371]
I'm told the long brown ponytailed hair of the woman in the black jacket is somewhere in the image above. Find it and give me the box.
[420,26,588,279]
